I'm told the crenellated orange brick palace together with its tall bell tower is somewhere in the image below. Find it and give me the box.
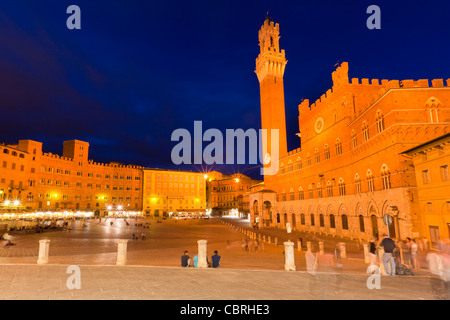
[250,19,450,239]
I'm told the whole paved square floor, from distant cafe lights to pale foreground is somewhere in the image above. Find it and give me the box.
[0,218,448,300]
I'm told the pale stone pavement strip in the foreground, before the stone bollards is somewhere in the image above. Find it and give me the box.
[0,265,448,300]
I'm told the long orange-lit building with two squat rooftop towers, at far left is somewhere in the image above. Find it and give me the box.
[0,140,142,215]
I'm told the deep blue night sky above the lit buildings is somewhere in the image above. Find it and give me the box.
[0,0,450,178]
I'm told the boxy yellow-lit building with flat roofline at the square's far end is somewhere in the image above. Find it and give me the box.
[143,168,206,217]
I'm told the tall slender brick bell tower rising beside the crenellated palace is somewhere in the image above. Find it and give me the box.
[255,17,287,172]
